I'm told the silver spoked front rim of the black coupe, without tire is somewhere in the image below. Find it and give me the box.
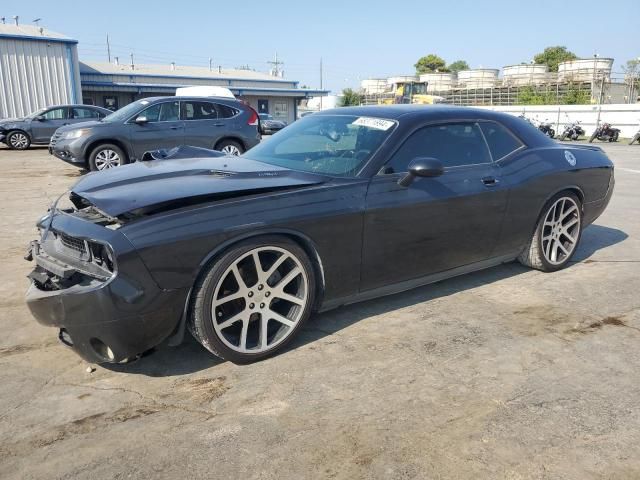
[211,246,309,353]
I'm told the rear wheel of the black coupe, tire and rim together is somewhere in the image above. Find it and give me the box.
[518,192,582,272]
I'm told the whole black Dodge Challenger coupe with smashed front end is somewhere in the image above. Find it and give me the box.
[27,105,614,363]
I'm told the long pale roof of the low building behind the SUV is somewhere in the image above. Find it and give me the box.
[80,62,298,83]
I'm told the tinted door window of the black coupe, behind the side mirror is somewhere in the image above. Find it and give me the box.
[387,122,491,173]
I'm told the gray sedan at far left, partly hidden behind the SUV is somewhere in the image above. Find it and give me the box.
[0,105,111,150]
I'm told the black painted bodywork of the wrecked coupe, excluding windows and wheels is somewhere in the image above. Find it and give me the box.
[27,105,614,361]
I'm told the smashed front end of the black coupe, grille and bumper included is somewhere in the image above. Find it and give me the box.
[25,189,187,363]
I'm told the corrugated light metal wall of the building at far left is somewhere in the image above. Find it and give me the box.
[0,37,82,118]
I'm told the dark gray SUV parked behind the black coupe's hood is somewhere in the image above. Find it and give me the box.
[49,97,260,170]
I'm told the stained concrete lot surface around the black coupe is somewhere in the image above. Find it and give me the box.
[0,144,640,480]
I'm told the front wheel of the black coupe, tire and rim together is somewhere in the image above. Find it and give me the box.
[189,236,315,363]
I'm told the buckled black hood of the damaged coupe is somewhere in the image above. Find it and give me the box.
[71,148,328,218]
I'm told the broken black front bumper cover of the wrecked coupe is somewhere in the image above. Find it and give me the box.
[26,215,188,363]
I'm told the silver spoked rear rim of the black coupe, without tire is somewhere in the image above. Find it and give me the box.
[541,197,580,265]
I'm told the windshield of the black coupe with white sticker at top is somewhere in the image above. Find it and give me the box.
[245,115,396,177]
